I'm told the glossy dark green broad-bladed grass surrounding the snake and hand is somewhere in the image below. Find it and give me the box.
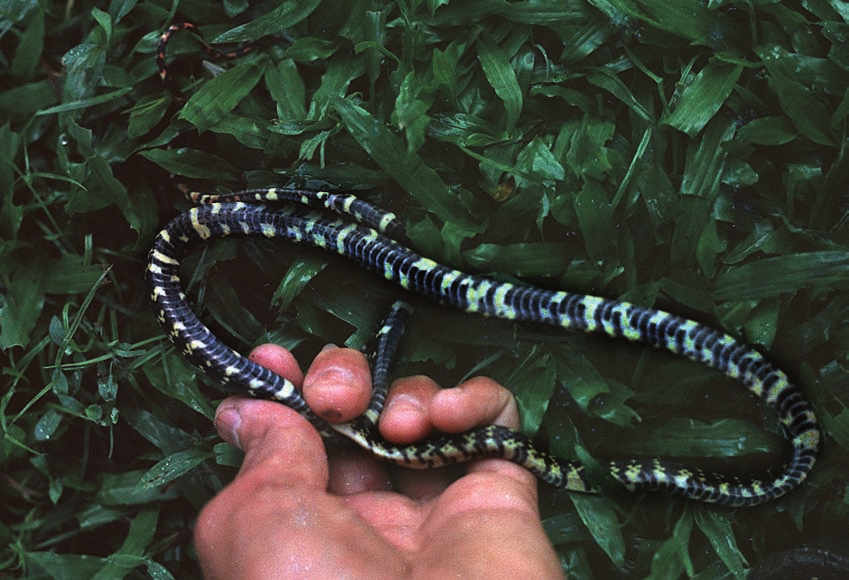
[0,0,849,579]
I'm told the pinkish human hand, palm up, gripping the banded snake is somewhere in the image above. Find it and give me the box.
[195,345,563,580]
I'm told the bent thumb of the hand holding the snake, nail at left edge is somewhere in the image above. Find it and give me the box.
[215,397,328,489]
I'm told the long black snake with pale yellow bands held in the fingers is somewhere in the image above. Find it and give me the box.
[146,189,820,506]
